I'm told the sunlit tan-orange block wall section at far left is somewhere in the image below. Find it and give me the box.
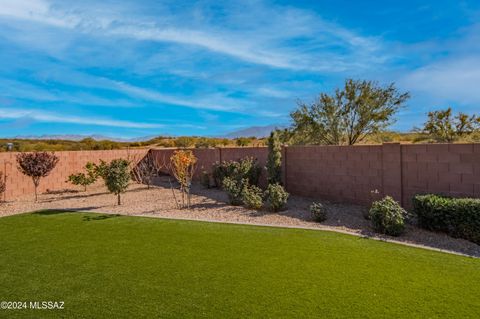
[0,149,148,200]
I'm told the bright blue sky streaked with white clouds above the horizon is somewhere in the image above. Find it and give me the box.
[0,0,480,137]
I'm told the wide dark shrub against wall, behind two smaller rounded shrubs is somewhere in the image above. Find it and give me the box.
[213,157,262,187]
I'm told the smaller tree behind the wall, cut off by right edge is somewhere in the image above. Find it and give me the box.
[422,107,480,143]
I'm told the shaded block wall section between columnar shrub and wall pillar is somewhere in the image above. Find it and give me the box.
[285,146,382,203]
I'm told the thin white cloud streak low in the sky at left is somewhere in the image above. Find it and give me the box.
[0,107,164,129]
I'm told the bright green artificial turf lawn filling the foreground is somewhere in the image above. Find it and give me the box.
[0,212,480,318]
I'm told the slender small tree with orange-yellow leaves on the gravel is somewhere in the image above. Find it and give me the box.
[170,150,197,207]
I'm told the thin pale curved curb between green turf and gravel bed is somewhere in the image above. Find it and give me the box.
[9,209,480,259]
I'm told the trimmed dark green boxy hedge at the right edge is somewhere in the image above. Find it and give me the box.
[413,194,480,244]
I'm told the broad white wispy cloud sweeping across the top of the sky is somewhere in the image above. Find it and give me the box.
[0,0,386,72]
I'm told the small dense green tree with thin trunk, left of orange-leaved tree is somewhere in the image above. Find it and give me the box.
[104,159,130,205]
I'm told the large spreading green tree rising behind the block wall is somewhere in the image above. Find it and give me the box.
[290,79,410,145]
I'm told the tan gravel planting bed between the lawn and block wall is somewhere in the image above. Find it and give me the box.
[0,178,480,257]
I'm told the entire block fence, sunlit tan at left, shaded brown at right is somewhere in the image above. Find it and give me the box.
[0,143,480,208]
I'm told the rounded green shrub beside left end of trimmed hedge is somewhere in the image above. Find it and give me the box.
[369,196,407,236]
